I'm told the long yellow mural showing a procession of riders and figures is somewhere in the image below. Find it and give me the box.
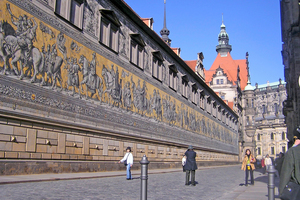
[0,1,237,144]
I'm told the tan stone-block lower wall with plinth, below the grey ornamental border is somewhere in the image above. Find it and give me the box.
[0,118,238,175]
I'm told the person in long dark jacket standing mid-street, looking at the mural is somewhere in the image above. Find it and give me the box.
[183,145,198,186]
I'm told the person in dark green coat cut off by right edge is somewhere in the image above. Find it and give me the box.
[279,129,300,200]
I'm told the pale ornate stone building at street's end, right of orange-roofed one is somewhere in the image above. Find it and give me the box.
[243,79,288,159]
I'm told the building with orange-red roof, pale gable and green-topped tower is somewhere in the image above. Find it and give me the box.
[185,19,250,158]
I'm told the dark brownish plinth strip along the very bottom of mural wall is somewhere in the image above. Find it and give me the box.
[0,158,238,175]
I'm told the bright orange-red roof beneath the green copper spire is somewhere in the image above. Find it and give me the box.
[204,53,248,90]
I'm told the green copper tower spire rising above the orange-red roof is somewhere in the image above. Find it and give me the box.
[216,13,232,56]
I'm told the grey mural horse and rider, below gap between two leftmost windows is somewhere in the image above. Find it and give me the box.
[78,55,103,101]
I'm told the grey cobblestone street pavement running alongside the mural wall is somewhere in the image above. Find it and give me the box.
[0,166,280,200]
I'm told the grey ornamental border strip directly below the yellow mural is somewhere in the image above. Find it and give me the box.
[0,75,235,153]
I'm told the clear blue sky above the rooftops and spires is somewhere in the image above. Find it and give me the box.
[125,0,284,86]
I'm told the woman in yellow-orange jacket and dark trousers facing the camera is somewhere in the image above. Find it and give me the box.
[241,149,256,186]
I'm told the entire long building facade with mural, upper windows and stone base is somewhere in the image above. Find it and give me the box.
[0,0,239,174]
